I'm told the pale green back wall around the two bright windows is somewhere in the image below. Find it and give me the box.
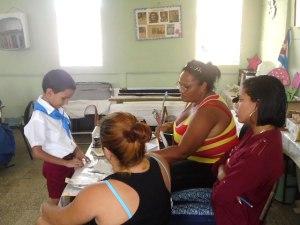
[0,0,262,117]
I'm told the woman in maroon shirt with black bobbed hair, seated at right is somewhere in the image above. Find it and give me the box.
[212,76,287,225]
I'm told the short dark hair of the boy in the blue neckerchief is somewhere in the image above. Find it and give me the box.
[42,69,76,93]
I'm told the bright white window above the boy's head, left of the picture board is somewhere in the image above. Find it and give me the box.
[55,0,102,67]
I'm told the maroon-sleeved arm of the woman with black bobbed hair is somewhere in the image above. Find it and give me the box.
[212,141,274,205]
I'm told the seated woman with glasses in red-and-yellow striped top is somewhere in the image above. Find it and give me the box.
[157,60,237,191]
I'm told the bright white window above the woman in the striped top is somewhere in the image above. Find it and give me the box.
[195,0,242,65]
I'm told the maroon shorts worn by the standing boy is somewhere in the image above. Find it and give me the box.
[43,155,74,199]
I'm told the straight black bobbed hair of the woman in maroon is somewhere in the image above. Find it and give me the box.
[243,75,287,127]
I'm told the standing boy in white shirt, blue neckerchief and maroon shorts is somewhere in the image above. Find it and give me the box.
[24,70,85,205]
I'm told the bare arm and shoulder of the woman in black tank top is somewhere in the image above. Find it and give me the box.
[39,180,139,225]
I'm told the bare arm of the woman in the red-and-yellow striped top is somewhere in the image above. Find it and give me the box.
[156,107,224,163]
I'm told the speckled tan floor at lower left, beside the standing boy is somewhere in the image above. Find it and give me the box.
[0,139,47,225]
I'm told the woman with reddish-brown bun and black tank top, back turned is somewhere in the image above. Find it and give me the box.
[37,112,171,225]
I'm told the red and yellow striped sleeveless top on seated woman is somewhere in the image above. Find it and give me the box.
[173,94,238,163]
